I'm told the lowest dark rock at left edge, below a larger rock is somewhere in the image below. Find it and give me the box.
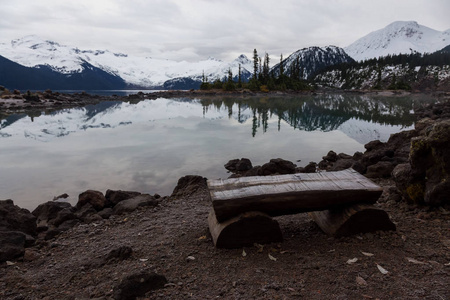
[0,231,26,262]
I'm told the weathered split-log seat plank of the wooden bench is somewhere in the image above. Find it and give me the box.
[208,169,382,222]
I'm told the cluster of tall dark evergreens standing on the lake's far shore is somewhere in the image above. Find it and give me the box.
[200,49,312,92]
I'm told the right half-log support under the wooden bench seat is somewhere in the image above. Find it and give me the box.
[309,204,396,236]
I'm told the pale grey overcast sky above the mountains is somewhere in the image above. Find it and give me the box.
[0,0,450,61]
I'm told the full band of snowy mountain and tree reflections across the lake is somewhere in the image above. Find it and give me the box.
[0,94,431,141]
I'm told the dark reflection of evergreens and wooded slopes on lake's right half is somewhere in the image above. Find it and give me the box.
[201,94,426,137]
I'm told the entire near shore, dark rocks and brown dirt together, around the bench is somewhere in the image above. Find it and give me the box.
[0,94,450,299]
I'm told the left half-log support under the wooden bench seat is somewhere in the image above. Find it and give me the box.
[208,209,283,248]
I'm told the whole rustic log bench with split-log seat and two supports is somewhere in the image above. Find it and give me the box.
[208,169,395,248]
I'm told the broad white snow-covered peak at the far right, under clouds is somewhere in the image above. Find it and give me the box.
[344,21,450,61]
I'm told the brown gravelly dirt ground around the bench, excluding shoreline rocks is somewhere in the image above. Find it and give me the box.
[0,180,450,300]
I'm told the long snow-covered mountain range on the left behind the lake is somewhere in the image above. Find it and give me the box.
[0,35,252,88]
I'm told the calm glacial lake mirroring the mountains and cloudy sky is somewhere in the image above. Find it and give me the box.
[0,94,433,210]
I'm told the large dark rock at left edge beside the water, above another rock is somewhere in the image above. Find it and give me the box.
[0,200,37,236]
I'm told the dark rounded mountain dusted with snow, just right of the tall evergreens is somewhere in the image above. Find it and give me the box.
[272,46,353,79]
